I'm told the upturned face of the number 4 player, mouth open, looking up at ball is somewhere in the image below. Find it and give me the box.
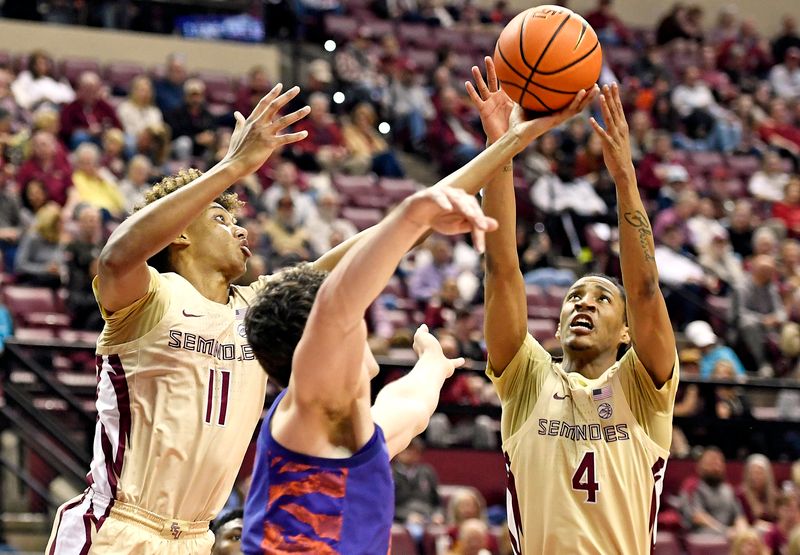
[556,276,629,354]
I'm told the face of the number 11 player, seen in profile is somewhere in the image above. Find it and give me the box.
[186,202,251,281]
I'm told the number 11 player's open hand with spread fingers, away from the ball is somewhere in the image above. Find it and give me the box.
[223,83,311,176]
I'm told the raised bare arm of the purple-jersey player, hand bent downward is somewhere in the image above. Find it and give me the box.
[289,187,497,412]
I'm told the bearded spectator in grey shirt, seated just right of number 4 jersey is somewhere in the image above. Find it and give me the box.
[681,447,747,537]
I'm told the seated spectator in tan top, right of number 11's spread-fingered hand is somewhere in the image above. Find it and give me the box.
[342,102,405,177]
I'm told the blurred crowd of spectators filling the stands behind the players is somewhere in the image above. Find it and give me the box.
[0,0,800,554]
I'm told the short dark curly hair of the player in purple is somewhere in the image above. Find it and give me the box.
[244,263,328,387]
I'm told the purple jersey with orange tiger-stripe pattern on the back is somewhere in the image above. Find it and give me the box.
[242,392,394,555]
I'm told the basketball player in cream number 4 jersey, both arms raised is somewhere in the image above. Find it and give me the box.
[467,58,678,555]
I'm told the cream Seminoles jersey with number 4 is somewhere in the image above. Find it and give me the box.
[487,335,678,555]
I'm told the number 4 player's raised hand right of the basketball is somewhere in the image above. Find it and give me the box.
[589,83,636,182]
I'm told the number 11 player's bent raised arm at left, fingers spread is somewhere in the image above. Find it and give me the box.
[97,84,309,312]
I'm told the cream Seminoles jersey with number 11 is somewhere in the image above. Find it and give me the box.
[87,268,268,522]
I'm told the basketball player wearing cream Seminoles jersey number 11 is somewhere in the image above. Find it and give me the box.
[47,85,330,555]
